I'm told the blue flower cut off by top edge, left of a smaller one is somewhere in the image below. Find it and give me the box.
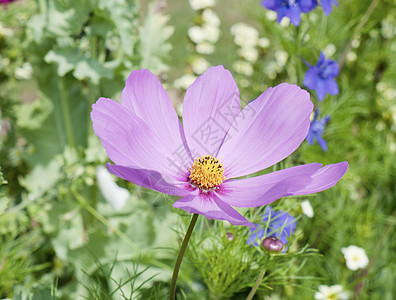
[261,0,318,26]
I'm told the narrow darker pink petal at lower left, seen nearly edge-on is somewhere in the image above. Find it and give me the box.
[106,164,189,196]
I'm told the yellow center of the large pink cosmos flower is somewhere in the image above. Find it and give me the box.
[189,155,225,190]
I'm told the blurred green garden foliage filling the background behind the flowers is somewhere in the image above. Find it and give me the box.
[0,0,396,300]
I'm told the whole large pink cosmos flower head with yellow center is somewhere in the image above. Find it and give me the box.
[91,66,348,227]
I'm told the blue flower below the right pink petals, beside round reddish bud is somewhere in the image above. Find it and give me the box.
[247,206,296,246]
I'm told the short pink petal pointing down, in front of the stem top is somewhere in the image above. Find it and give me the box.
[173,193,254,227]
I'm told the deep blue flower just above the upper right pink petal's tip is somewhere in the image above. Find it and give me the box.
[303,51,339,101]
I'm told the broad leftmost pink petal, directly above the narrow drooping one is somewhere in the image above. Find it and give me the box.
[91,98,187,178]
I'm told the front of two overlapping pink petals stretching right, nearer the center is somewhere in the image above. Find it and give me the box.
[218,163,321,207]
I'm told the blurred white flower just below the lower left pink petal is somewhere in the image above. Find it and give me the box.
[96,166,131,211]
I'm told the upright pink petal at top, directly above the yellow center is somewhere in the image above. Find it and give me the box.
[183,66,241,158]
